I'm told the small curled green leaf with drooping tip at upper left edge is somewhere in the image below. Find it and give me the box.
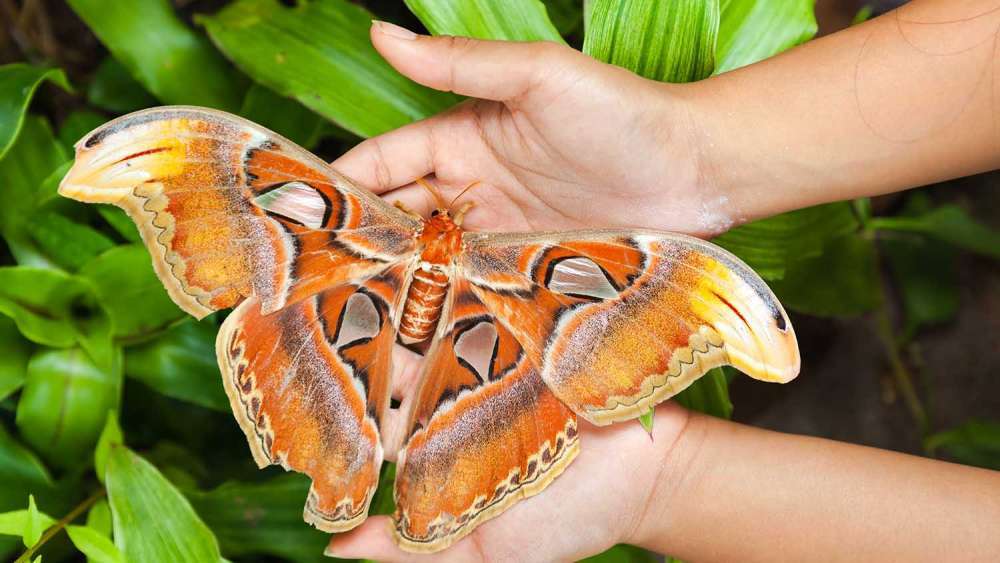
[0,63,72,159]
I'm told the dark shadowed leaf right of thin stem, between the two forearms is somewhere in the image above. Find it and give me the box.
[879,233,959,341]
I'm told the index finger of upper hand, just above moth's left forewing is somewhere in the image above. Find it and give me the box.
[333,117,437,193]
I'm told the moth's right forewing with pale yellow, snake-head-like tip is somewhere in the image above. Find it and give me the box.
[461,230,799,425]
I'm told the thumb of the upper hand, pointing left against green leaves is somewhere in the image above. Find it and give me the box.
[371,20,587,101]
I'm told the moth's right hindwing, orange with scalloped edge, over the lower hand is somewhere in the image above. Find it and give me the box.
[394,278,579,552]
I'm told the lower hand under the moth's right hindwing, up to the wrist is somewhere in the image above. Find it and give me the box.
[327,403,688,561]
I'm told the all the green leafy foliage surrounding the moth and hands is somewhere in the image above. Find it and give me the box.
[0,0,1000,563]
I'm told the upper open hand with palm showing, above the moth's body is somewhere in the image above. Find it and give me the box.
[333,22,730,235]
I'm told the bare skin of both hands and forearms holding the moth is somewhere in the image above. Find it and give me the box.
[330,0,1000,561]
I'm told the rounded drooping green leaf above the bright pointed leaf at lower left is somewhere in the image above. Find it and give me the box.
[17,348,121,467]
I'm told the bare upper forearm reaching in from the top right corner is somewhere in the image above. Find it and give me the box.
[680,0,1000,224]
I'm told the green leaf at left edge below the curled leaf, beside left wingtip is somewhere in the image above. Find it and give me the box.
[0,115,69,249]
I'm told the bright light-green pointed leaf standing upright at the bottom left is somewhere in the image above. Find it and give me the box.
[106,446,221,562]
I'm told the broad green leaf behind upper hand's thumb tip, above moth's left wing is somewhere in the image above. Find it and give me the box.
[196,0,458,137]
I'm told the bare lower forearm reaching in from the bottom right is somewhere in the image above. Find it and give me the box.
[631,414,1000,561]
